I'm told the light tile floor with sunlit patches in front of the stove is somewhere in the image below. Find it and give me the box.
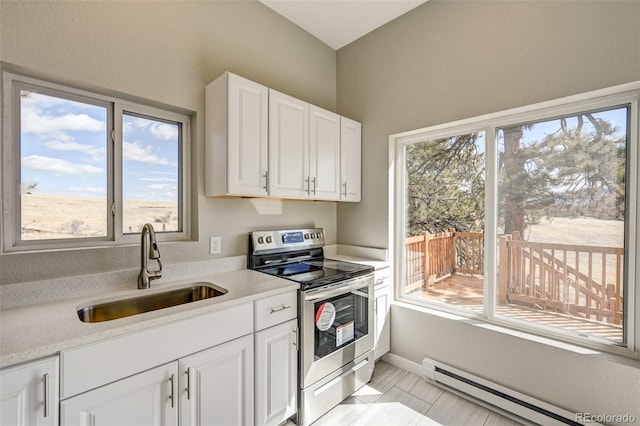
[304,361,519,426]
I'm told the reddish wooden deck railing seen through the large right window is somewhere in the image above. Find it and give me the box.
[405,229,624,325]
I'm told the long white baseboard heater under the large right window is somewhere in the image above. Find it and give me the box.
[422,358,600,426]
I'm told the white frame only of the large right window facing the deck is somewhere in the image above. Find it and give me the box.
[389,81,640,359]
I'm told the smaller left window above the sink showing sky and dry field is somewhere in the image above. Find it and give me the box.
[3,73,189,251]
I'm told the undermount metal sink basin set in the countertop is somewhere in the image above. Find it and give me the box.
[78,283,227,322]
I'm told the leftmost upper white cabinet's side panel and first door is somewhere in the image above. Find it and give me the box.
[205,72,269,197]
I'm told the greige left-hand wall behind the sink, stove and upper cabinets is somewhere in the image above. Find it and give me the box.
[0,1,336,284]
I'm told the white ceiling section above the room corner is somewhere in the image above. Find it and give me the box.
[260,0,427,50]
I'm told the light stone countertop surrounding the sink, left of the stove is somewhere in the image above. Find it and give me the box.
[0,269,299,368]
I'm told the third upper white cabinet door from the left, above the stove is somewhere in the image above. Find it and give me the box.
[309,105,340,201]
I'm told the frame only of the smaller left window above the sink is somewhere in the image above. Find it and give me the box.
[0,71,191,253]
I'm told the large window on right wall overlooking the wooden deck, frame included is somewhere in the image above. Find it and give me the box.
[390,83,640,356]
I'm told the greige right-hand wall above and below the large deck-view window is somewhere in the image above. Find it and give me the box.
[337,0,640,419]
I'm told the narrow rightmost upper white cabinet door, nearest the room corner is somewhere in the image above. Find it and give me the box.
[340,117,362,202]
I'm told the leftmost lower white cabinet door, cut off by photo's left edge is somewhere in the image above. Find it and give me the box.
[0,357,58,426]
